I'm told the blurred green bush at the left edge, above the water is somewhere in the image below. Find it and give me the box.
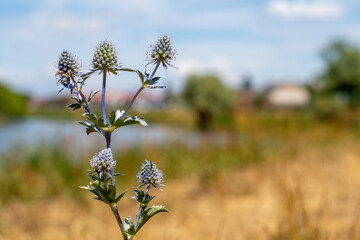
[0,85,27,117]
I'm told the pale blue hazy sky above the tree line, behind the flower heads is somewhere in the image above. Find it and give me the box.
[0,0,360,96]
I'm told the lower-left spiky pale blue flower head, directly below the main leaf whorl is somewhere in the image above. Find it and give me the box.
[90,148,116,178]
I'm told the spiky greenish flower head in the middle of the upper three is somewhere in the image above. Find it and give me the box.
[92,40,119,71]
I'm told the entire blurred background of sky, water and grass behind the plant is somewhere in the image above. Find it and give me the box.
[0,0,360,240]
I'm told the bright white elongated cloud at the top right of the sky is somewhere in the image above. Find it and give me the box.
[267,0,345,19]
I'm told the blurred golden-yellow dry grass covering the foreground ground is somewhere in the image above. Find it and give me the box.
[0,133,360,240]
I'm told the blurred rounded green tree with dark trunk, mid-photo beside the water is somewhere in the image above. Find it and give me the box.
[183,75,233,130]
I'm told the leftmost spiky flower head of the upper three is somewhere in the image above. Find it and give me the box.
[55,50,81,89]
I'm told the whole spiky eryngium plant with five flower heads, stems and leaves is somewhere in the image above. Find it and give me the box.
[55,35,176,240]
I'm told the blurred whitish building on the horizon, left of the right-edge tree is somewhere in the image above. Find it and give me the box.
[266,84,310,108]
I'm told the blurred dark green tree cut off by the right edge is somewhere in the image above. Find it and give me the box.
[320,41,360,106]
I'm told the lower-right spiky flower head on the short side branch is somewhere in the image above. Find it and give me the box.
[136,160,164,189]
